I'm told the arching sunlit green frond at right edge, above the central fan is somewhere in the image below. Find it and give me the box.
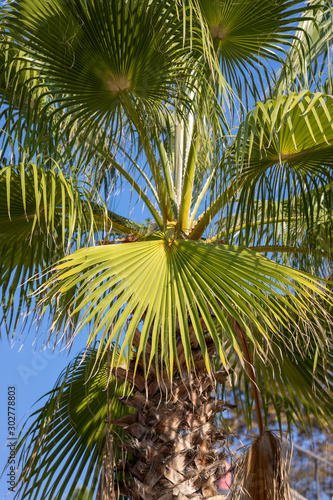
[224,91,333,252]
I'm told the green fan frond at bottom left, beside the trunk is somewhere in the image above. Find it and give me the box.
[16,349,132,500]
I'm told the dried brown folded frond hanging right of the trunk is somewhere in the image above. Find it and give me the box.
[233,431,291,500]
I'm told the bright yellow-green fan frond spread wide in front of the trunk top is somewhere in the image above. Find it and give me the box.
[40,235,330,376]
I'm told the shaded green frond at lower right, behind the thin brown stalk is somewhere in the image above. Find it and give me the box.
[231,336,333,431]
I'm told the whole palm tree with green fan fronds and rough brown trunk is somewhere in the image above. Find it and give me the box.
[0,0,333,500]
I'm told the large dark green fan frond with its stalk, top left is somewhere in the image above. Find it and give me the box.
[3,0,220,221]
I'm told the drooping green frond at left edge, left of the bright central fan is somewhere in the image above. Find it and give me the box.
[0,163,106,334]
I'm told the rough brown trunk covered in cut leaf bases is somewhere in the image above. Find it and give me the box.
[111,330,231,500]
